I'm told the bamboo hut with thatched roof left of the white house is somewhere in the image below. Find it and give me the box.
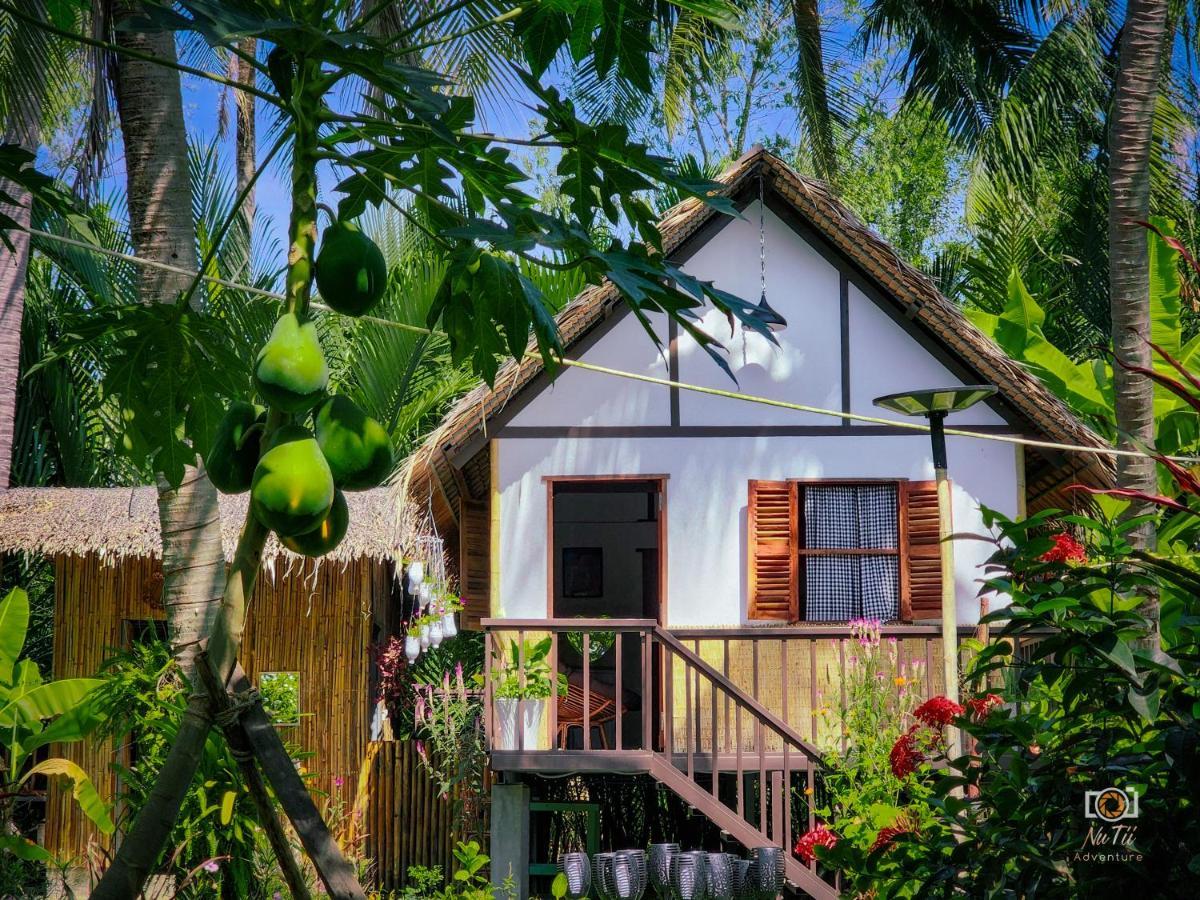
[0,487,451,886]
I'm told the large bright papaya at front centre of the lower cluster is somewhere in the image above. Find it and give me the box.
[250,425,334,538]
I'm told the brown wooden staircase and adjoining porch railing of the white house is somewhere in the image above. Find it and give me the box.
[482,619,839,900]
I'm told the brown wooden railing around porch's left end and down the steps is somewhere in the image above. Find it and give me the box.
[484,619,873,896]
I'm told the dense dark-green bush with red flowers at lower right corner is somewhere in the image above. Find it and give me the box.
[822,508,1200,898]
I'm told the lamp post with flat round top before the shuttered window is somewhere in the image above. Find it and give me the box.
[874,384,996,754]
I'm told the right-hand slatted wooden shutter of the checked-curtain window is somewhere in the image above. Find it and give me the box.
[900,481,942,622]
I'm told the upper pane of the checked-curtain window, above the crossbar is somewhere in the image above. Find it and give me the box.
[803,485,899,550]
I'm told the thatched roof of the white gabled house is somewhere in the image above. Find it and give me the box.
[409,148,1114,496]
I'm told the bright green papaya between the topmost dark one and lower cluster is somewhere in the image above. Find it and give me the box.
[254,312,329,413]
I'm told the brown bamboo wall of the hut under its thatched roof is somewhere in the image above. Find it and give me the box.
[46,556,390,859]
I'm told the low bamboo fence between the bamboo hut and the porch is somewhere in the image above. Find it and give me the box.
[365,740,487,890]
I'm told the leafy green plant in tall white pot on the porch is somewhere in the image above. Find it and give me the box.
[492,637,566,750]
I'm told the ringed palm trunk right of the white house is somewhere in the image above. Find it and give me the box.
[1109,0,1166,566]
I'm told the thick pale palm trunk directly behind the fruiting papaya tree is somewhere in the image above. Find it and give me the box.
[114,0,224,680]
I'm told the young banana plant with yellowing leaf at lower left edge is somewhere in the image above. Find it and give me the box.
[0,588,113,863]
